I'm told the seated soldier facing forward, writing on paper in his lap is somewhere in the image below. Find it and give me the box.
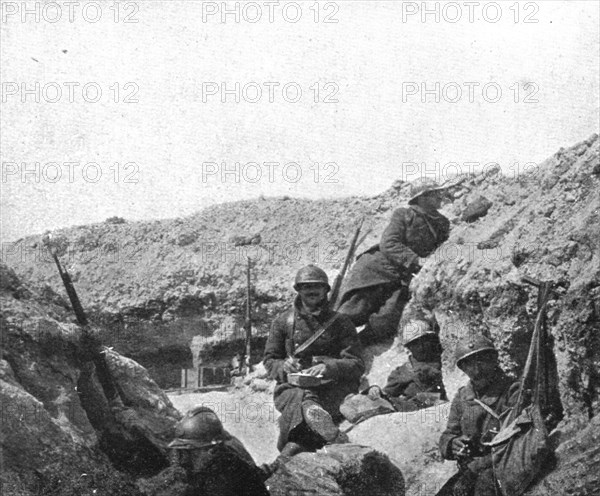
[264,265,364,464]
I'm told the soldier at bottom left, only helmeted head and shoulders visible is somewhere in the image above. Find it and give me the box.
[169,406,269,496]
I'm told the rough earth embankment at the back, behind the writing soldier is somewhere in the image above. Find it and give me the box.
[5,178,409,387]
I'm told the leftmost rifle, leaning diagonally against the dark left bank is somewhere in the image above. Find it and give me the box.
[42,235,120,403]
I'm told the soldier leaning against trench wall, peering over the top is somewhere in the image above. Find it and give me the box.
[338,182,450,344]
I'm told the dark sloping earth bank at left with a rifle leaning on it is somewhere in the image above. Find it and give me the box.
[0,264,179,496]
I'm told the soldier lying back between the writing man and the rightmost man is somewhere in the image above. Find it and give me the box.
[383,320,447,411]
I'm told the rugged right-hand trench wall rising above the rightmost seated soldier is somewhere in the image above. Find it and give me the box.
[406,135,600,418]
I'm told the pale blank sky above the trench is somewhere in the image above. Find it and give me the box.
[0,0,600,242]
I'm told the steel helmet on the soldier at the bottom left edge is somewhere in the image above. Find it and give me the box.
[169,406,230,449]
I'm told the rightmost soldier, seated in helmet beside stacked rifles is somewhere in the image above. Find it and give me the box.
[438,335,519,496]
